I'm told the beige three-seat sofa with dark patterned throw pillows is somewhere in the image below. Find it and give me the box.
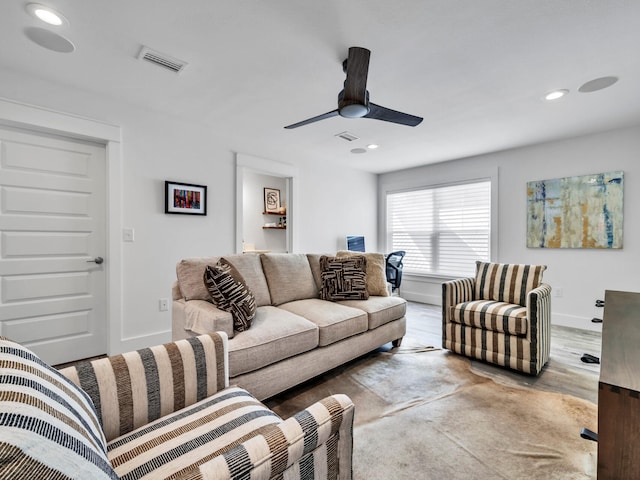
[172,254,406,400]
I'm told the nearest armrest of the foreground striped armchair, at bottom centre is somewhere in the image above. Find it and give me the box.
[189,394,354,480]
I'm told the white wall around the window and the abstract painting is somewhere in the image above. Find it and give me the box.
[379,127,640,330]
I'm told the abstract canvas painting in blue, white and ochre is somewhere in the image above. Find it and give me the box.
[527,172,624,248]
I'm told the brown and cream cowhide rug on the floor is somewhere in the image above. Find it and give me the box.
[270,347,597,480]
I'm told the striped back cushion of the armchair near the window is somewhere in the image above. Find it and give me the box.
[475,261,547,307]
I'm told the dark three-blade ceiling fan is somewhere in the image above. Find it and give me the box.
[284,47,422,128]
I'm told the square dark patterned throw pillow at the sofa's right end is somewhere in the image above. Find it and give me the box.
[320,256,369,301]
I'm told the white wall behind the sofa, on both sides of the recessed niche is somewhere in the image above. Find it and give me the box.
[0,69,377,353]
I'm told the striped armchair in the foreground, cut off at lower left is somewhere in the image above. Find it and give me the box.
[0,332,354,480]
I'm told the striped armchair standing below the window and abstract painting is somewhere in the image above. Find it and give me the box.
[442,262,551,375]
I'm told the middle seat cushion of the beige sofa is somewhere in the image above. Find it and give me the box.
[280,298,369,347]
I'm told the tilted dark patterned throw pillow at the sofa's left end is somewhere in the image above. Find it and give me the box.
[204,258,256,332]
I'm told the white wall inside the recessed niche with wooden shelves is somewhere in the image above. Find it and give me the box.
[242,169,287,252]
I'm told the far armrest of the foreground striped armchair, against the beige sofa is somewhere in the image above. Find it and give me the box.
[60,332,229,441]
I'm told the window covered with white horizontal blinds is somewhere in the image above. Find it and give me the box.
[387,180,491,277]
